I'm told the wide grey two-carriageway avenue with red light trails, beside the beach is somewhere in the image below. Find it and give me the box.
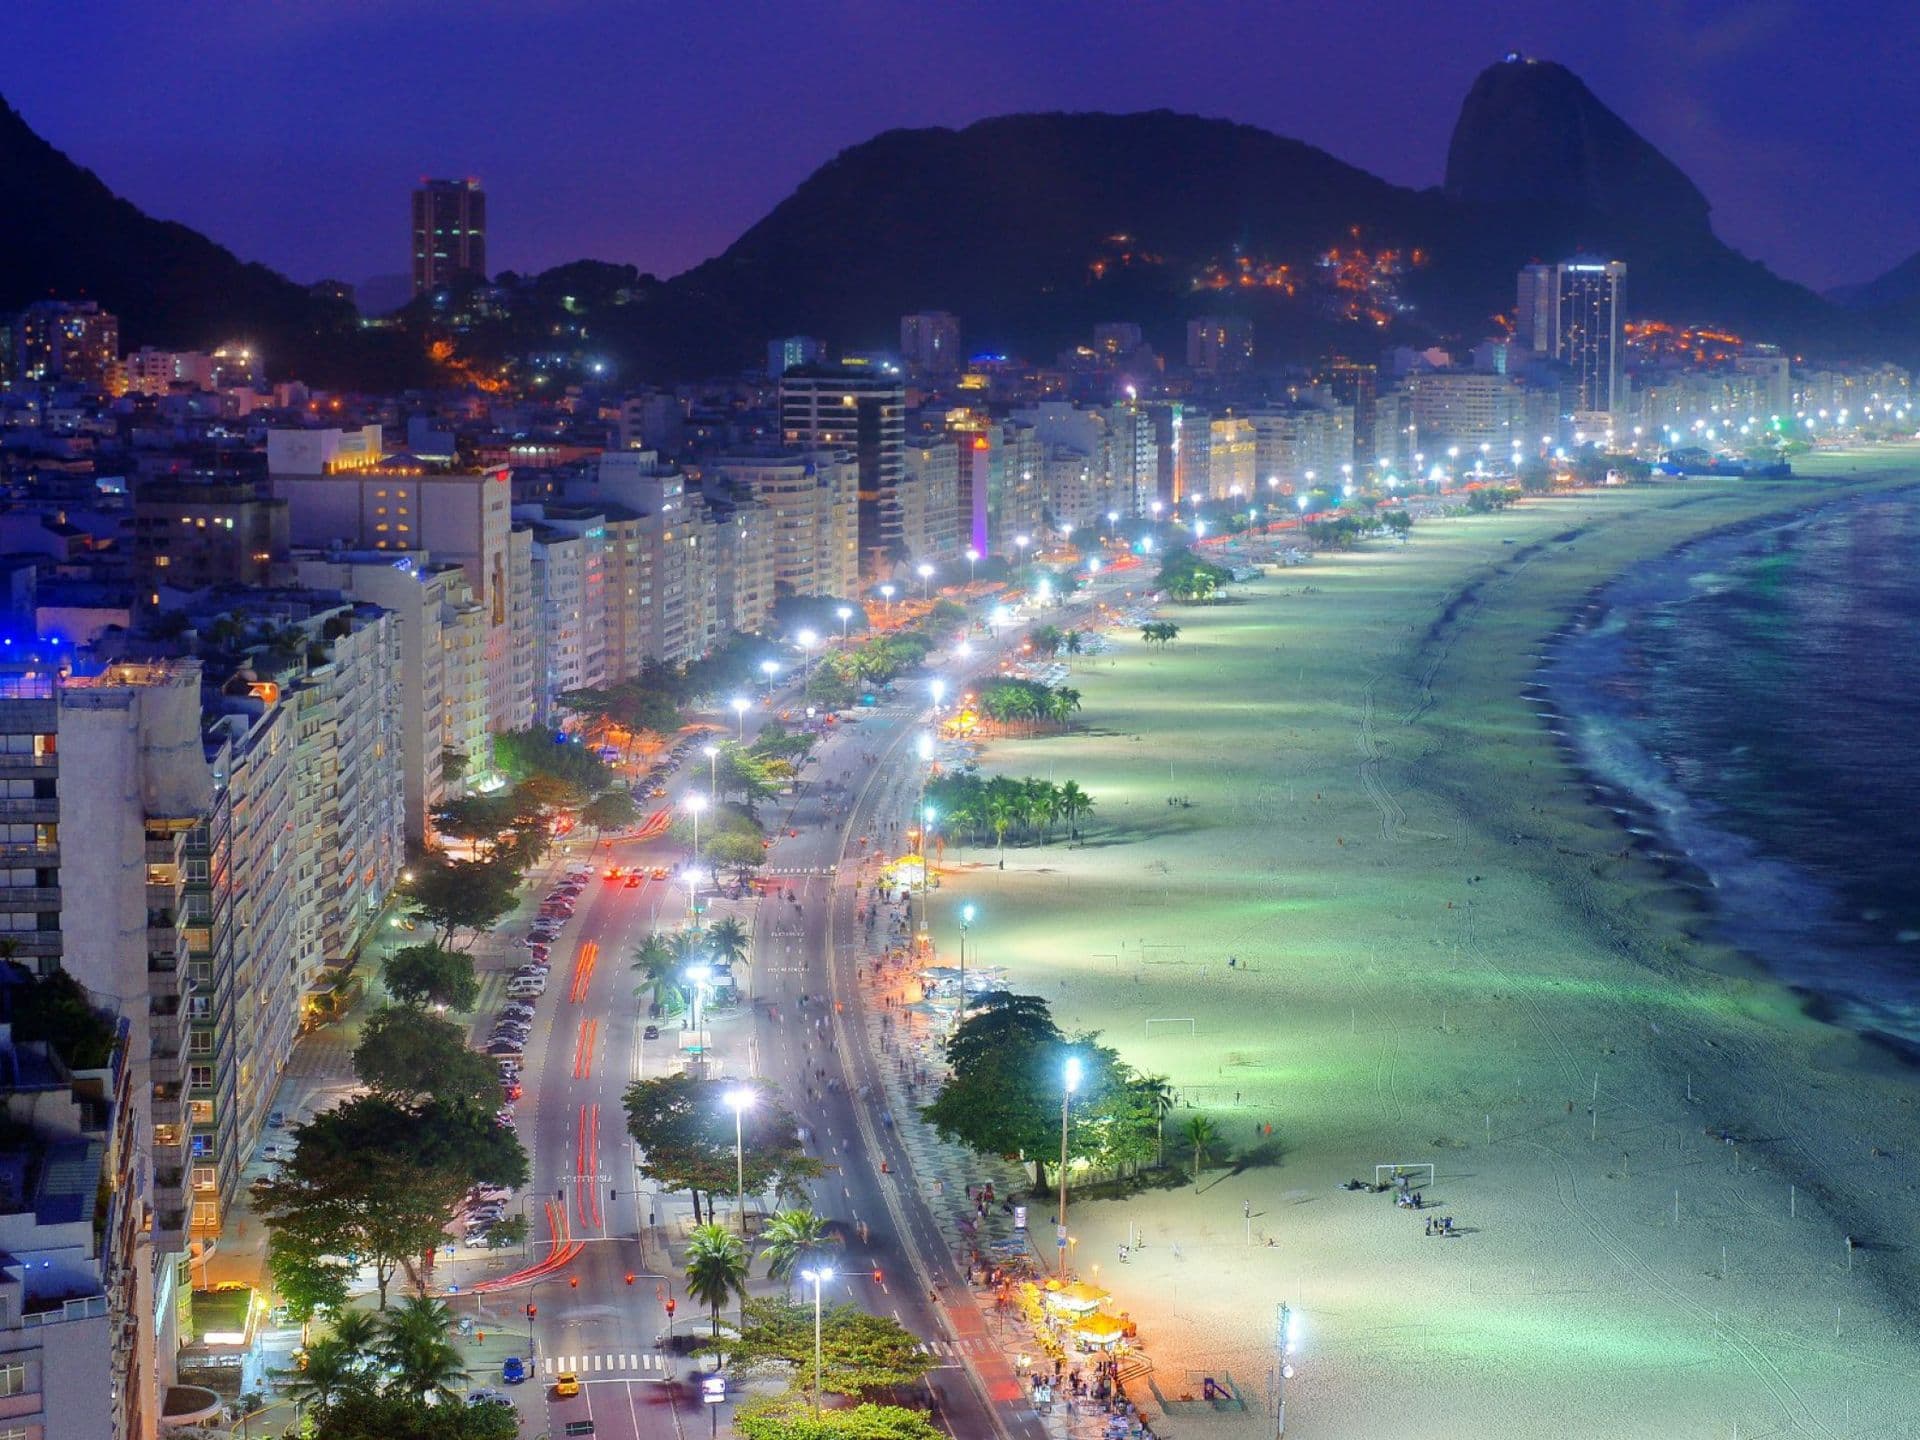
[474,659,1046,1440]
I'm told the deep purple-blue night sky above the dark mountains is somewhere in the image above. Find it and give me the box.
[0,0,1920,295]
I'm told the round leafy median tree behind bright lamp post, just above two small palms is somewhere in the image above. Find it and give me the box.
[624,1073,820,1215]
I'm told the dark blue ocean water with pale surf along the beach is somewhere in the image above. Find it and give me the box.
[1542,480,1920,1056]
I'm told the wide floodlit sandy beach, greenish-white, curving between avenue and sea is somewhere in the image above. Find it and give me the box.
[933,464,1920,1440]
